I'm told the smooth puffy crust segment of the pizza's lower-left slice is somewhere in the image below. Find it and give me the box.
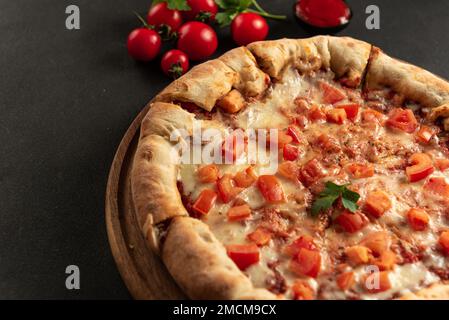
[162,217,276,300]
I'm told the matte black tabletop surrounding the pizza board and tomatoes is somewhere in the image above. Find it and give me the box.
[0,0,449,299]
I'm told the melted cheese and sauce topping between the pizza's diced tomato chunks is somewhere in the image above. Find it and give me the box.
[179,69,449,299]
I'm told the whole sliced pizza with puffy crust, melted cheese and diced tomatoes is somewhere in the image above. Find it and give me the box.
[131,36,449,300]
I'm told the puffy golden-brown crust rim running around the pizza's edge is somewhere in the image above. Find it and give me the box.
[131,36,449,299]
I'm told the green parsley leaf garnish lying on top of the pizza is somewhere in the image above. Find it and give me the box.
[312,181,360,216]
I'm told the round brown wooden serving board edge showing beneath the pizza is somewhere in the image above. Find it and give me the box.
[105,106,186,300]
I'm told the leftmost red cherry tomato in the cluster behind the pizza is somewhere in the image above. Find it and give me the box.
[127,28,161,61]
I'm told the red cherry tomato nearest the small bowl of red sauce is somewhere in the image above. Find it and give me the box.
[231,12,269,46]
